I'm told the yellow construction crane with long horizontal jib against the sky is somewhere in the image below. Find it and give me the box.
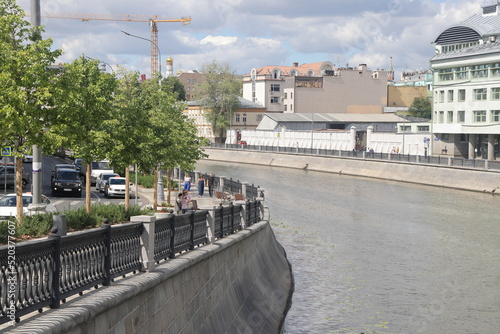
[34,13,191,75]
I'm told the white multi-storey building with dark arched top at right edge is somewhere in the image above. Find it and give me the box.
[430,0,500,160]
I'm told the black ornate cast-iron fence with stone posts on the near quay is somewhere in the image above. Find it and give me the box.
[0,178,267,324]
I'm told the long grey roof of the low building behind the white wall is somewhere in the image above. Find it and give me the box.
[266,113,404,123]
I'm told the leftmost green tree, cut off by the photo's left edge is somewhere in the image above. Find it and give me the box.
[0,0,61,223]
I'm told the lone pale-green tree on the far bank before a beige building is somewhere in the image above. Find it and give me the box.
[200,61,243,143]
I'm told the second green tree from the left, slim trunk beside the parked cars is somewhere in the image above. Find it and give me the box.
[51,55,117,213]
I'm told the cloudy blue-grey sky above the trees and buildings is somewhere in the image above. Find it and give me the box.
[17,0,484,79]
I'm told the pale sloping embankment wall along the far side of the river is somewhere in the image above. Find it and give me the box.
[205,148,500,193]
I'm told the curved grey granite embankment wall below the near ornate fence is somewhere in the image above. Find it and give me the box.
[8,221,293,334]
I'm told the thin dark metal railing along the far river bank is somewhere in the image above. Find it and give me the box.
[211,143,500,171]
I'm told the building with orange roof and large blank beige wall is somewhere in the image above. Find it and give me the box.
[243,61,387,114]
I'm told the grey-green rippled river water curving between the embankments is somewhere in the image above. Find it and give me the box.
[197,161,500,334]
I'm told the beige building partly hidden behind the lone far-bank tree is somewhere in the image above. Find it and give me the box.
[184,97,266,143]
